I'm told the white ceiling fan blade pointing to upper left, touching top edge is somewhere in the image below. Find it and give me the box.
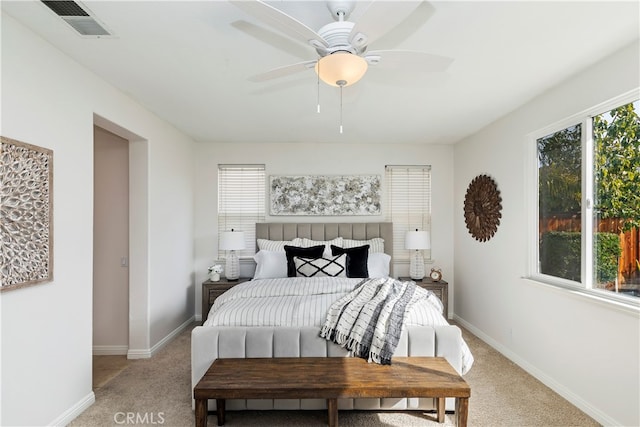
[230,0,329,48]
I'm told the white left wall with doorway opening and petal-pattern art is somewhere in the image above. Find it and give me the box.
[0,13,194,425]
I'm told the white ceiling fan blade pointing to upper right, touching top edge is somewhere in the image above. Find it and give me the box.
[349,1,422,47]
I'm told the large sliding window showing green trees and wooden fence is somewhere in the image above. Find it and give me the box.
[533,100,640,303]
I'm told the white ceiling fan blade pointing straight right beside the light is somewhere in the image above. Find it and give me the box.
[364,50,453,72]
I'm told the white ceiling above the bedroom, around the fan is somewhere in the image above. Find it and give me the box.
[1,0,640,144]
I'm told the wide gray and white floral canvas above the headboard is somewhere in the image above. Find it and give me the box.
[270,175,381,216]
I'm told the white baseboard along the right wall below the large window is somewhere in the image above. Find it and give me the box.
[453,314,622,426]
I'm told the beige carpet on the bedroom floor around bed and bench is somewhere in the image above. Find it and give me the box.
[70,324,599,427]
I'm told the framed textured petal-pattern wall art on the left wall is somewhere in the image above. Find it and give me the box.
[0,137,53,291]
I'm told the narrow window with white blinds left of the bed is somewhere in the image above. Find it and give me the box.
[218,165,266,257]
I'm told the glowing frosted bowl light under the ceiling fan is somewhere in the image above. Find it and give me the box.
[315,52,369,87]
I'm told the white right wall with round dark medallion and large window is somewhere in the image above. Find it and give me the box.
[454,43,640,426]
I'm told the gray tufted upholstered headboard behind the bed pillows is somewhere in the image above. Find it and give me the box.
[256,222,393,277]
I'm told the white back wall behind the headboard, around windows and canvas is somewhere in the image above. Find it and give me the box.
[195,142,455,317]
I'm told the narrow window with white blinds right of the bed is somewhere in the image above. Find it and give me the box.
[385,165,431,262]
